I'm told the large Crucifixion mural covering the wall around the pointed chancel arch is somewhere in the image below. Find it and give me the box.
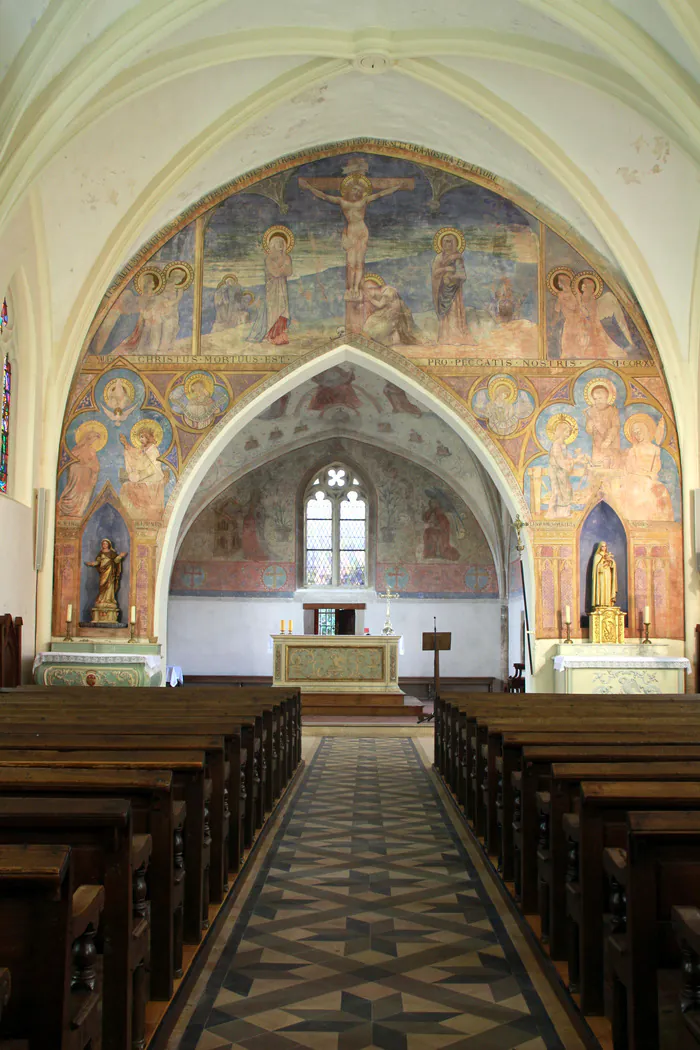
[55,140,683,637]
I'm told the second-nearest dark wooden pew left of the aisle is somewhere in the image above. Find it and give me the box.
[0,798,151,1050]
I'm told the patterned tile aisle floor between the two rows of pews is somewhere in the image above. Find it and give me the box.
[169,737,582,1050]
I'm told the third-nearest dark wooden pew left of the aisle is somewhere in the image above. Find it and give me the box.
[0,767,180,1000]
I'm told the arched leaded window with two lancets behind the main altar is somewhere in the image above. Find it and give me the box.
[304,463,367,587]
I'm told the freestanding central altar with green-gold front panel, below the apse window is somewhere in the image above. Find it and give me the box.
[272,634,401,694]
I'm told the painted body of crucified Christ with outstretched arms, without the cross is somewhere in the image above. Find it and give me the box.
[299,172,412,300]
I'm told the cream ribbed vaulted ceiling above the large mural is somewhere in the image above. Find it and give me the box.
[0,0,700,472]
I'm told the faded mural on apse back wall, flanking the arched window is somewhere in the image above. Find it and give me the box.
[171,439,499,599]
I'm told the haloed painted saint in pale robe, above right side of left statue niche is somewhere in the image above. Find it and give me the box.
[120,419,166,521]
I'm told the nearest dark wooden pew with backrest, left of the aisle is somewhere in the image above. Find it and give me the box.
[0,845,104,1050]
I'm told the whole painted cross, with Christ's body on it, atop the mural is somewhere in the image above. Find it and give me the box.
[299,171,416,335]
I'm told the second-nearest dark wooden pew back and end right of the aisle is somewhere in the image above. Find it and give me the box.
[564,780,700,1014]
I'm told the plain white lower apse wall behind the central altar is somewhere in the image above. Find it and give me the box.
[167,597,501,677]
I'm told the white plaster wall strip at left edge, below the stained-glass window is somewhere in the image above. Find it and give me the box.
[0,496,37,678]
